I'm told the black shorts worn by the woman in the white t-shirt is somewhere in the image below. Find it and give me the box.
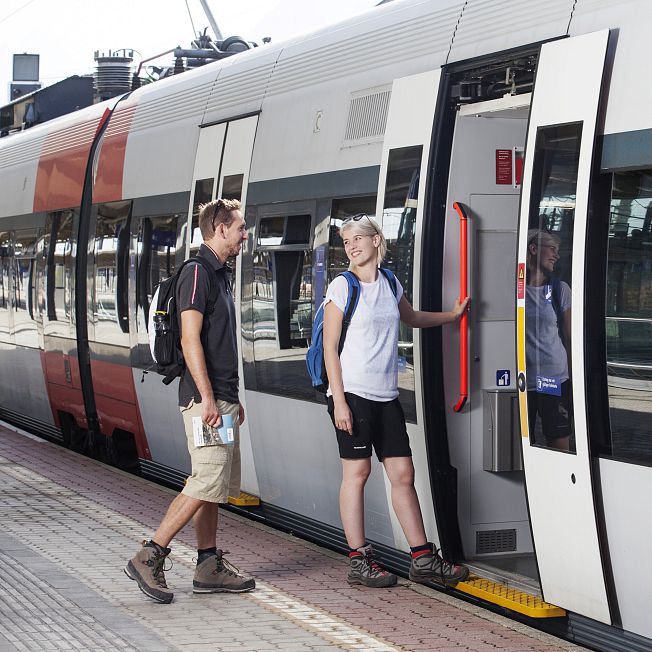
[328,392,412,462]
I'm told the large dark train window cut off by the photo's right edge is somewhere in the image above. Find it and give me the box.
[602,170,652,464]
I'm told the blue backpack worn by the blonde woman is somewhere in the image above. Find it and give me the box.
[306,267,398,392]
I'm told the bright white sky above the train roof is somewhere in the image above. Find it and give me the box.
[0,0,378,104]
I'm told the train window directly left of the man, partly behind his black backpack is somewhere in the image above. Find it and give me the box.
[136,215,180,336]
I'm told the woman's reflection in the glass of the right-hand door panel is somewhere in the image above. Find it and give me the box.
[525,229,572,450]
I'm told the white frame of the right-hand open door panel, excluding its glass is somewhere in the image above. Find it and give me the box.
[517,30,612,624]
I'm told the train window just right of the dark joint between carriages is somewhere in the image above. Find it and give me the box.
[92,201,131,346]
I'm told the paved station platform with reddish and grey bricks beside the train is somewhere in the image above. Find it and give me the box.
[0,426,583,652]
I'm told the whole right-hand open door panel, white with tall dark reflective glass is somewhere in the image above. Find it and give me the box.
[517,31,611,623]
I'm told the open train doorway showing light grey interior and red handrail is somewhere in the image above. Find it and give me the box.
[442,93,538,593]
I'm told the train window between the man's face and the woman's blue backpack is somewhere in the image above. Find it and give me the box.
[251,215,314,399]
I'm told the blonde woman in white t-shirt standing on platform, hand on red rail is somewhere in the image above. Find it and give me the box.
[324,214,468,587]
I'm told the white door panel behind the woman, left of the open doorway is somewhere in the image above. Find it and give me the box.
[376,70,441,547]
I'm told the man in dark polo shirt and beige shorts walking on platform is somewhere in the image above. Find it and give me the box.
[125,199,255,604]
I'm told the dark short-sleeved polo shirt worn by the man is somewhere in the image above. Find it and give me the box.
[177,244,238,407]
